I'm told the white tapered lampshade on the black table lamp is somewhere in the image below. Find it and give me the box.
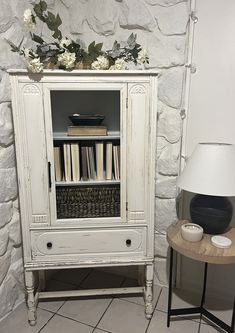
[177,143,235,196]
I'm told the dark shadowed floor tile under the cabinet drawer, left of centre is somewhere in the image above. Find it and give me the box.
[51,268,91,286]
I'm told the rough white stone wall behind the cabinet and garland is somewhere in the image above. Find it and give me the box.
[0,0,190,318]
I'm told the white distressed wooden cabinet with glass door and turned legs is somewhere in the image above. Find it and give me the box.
[9,70,157,325]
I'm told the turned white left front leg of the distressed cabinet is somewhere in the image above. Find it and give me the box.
[25,272,37,326]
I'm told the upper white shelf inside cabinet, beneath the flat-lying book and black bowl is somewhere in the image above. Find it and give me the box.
[53,132,120,141]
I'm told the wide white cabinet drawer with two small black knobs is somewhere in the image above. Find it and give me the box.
[31,228,146,257]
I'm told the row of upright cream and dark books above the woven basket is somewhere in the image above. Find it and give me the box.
[54,141,120,182]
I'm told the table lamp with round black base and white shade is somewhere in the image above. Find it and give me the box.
[177,143,235,235]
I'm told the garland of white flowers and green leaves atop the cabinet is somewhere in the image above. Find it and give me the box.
[10,0,148,73]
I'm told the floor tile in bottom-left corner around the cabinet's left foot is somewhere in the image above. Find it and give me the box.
[0,303,53,333]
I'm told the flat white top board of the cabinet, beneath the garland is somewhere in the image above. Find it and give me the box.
[7,69,159,77]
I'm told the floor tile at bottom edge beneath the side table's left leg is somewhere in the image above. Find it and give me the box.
[147,311,199,333]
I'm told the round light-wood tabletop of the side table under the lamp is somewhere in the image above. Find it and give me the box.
[167,220,235,264]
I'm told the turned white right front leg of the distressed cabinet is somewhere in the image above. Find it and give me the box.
[145,264,153,319]
